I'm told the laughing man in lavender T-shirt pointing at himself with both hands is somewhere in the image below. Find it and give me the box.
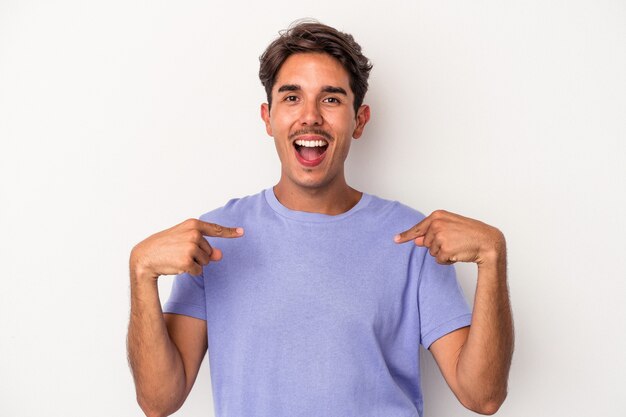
[128,22,513,417]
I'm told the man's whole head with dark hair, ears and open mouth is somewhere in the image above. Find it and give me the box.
[259,23,372,195]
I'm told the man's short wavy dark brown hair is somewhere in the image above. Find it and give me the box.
[259,20,372,113]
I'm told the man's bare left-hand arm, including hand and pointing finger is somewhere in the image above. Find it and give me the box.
[127,219,243,417]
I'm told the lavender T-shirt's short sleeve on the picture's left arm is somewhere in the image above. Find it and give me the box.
[163,273,206,320]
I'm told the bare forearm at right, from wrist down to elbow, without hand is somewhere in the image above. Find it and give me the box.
[457,249,514,413]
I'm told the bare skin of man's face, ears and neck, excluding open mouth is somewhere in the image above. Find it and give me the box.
[261,53,370,215]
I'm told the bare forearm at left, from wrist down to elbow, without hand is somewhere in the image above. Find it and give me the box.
[128,271,185,416]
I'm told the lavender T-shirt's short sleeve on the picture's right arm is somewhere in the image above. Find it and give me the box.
[418,250,472,349]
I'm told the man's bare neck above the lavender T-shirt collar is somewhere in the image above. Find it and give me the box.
[274,179,363,216]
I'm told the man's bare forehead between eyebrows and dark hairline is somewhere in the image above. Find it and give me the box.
[274,53,351,92]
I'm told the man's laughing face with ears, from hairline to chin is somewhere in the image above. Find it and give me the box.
[261,53,369,193]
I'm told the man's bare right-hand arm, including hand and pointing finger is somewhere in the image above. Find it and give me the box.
[396,210,513,414]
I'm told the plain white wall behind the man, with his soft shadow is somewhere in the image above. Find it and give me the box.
[0,0,626,417]
